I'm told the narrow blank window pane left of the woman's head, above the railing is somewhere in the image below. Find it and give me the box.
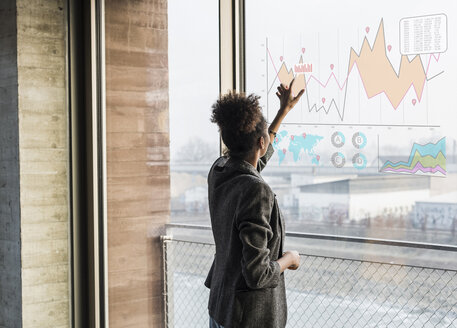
[168,0,219,223]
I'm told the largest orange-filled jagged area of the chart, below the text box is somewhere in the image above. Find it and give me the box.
[349,21,426,109]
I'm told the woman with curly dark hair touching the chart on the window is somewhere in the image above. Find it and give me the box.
[205,80,304,328]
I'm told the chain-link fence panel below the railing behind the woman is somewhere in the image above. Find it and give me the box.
[163,239,457,328]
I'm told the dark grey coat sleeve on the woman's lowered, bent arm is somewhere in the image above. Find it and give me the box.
[236,182,281,289]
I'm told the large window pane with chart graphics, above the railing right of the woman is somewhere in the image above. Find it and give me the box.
[246,0,457,244]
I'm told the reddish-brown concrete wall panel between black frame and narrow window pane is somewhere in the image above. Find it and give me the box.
[105,0,170,328]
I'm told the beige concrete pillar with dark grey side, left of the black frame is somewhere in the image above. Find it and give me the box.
[0,0,69,328]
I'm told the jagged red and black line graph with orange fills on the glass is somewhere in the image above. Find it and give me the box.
[266,20,443,120]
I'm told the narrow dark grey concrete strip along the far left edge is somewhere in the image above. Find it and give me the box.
[0,0,22,328]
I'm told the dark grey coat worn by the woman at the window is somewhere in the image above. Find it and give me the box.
[205,144,287,328]
